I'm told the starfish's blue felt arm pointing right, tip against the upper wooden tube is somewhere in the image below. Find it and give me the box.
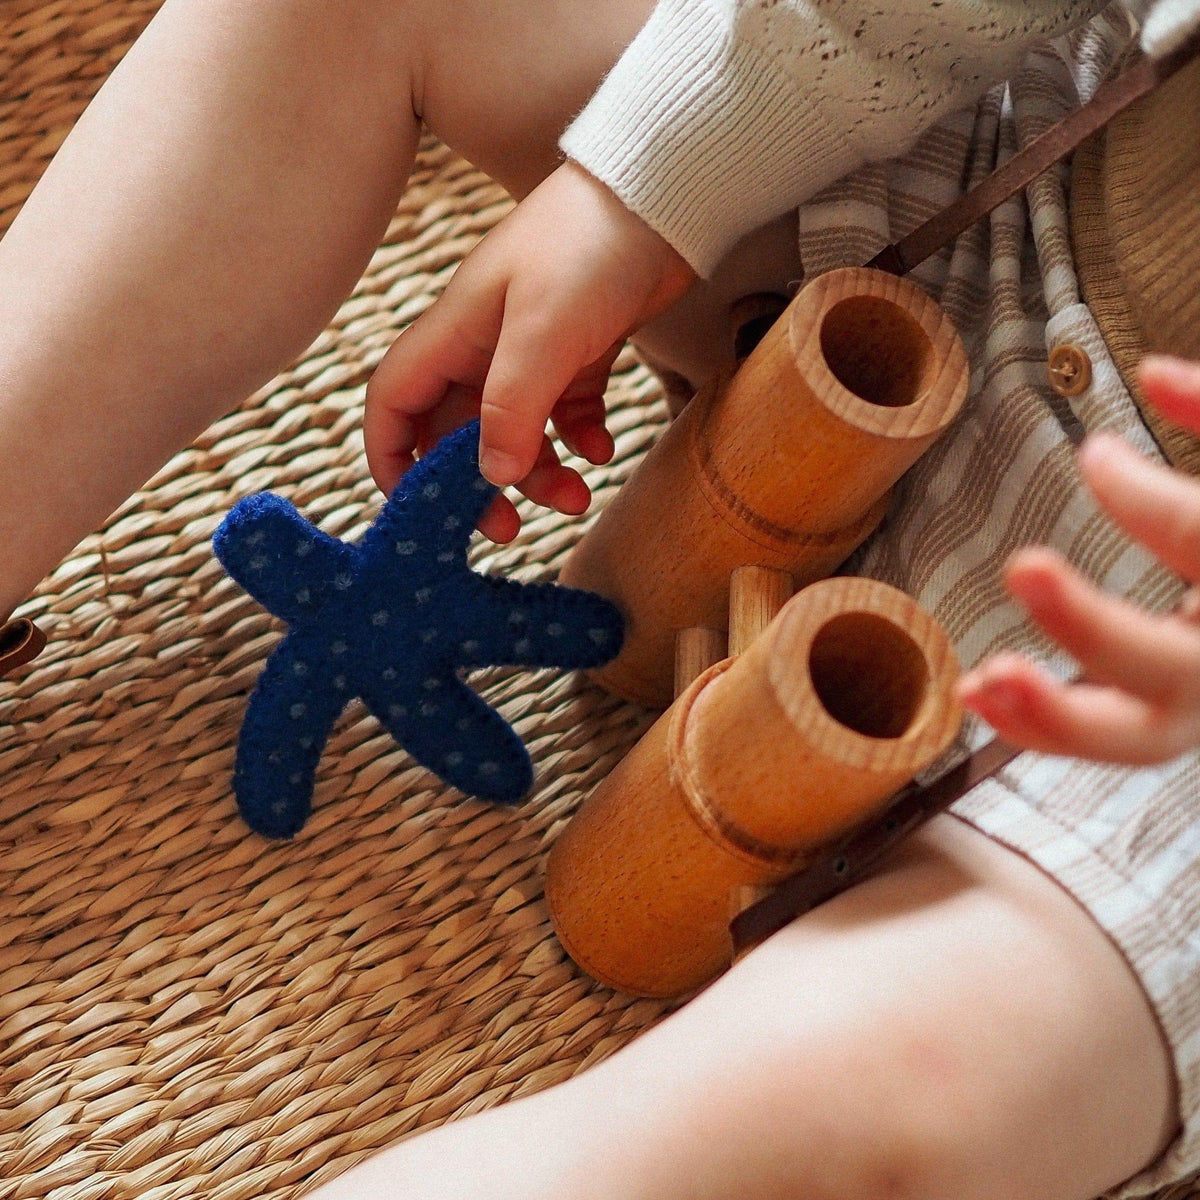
[460,575,624,671]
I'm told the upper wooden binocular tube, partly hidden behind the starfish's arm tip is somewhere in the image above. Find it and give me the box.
[562,269,967,707]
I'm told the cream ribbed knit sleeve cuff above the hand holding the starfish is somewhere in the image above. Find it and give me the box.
[562,0,862,277]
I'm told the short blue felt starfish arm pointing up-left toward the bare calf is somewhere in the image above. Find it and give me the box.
[212,492,355,625]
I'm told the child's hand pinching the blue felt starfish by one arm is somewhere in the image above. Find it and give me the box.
[364,162,696,541]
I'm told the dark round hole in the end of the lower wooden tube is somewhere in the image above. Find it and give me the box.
[809,612,929,738]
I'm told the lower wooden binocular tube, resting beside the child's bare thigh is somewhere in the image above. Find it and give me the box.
[546,578,961,996]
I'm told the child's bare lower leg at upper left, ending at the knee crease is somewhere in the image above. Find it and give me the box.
[0,0,419,616]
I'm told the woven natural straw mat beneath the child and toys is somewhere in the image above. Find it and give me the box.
[0,0,1200,1200]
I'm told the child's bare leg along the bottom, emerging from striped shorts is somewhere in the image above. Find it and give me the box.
[304,817,1176,1200]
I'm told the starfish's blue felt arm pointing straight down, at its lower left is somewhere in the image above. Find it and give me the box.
[233,636,348,838]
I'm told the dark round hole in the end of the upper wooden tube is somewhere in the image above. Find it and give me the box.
[821,296,934,408]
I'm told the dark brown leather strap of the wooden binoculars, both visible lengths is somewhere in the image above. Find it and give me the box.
[730,35,1200,954]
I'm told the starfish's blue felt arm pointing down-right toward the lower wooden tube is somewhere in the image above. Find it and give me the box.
[364,674,533,804]
